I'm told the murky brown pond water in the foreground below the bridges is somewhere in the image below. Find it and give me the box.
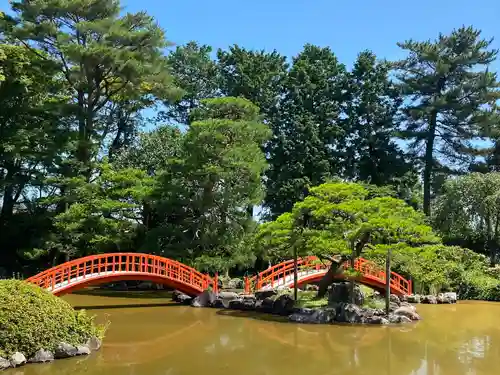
[5,293,500,375]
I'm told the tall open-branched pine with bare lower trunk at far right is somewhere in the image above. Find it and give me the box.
[396,27,500,214]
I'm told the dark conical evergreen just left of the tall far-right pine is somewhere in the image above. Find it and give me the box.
[344,51,416,186]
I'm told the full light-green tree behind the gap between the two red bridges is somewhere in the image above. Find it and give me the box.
[145,98,269,270]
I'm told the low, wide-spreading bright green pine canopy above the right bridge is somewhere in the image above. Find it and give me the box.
[256,182,439,259]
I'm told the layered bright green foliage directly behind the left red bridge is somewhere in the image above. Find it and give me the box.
[39,162,153,255]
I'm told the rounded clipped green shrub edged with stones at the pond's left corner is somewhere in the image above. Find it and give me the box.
[0,280,104,358]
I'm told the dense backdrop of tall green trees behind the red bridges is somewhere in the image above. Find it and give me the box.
[0,0,500,296]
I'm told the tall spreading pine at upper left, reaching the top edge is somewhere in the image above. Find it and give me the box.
[8,0,177,179]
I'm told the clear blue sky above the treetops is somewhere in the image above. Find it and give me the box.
[120,0,500,70]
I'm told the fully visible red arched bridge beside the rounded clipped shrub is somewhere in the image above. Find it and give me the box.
[26,253,218,296]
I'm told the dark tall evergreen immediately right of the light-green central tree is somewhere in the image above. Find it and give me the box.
[265,45,347,217]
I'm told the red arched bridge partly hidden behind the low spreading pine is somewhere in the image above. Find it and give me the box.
[245,256,412,295]
